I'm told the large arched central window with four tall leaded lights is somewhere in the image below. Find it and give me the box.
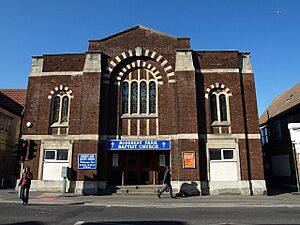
[121,69,157,117]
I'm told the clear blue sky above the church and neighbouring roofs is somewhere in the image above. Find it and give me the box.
[0,0,300,114]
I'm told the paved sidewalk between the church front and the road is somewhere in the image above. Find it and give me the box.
[0,189,300,208]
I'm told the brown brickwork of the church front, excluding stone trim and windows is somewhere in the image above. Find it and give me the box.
[23,25,263,186]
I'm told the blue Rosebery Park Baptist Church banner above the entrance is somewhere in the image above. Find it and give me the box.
[107,140,171,150]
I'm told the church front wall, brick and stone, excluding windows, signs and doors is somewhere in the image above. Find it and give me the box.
[23,26,264,193]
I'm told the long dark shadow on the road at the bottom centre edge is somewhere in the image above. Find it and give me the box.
[83,220,187,225]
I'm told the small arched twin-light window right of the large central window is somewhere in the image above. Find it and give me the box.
[209,90,229,125]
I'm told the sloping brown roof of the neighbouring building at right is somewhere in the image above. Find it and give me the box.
[259,83,300,125]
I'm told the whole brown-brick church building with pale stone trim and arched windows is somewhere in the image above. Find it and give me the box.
[22,26,266,195]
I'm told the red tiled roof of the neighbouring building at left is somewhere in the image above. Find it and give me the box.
[0,89,27,115]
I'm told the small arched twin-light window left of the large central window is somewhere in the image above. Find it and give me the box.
[51,91,70,125]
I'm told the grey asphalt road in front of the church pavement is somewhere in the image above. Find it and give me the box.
[0,203,300,225]
